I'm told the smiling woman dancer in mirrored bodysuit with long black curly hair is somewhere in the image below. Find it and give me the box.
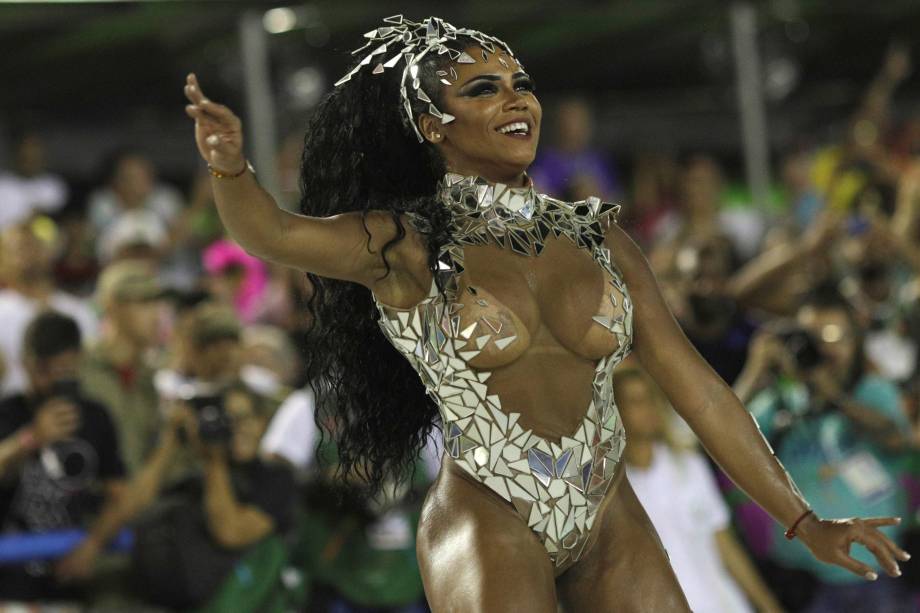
[185,16,907,612]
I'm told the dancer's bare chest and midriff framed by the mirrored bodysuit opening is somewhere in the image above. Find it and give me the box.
[459,238,617,442]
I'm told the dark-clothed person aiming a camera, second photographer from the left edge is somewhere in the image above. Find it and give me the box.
[73,383,296,609]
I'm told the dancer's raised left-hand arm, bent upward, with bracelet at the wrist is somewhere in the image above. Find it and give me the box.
[185,75,427,302]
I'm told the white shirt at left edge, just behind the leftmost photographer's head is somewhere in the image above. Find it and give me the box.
[0,289,99,395]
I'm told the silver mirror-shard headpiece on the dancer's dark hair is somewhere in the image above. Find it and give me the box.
[335,15,520,143]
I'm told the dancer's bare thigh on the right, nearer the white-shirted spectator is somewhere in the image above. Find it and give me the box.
[557,475,690,613]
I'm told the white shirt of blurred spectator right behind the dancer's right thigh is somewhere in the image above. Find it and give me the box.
[626,443,752,613]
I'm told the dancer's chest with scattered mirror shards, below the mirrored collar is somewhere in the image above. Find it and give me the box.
[455,238,629,368]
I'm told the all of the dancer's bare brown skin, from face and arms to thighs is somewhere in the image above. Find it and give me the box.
[185,26,908,613]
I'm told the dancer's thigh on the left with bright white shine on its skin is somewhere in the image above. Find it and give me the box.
[416,462,556,613]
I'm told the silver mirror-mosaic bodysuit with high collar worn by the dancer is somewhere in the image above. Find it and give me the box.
[377,174,632,568]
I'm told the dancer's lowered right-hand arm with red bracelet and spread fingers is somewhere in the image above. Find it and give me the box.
[607,225,907,579]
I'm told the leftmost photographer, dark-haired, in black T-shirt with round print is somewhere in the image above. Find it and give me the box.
[0,311,125,600]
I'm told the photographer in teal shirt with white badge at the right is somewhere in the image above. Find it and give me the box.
[735,286,910,612]
